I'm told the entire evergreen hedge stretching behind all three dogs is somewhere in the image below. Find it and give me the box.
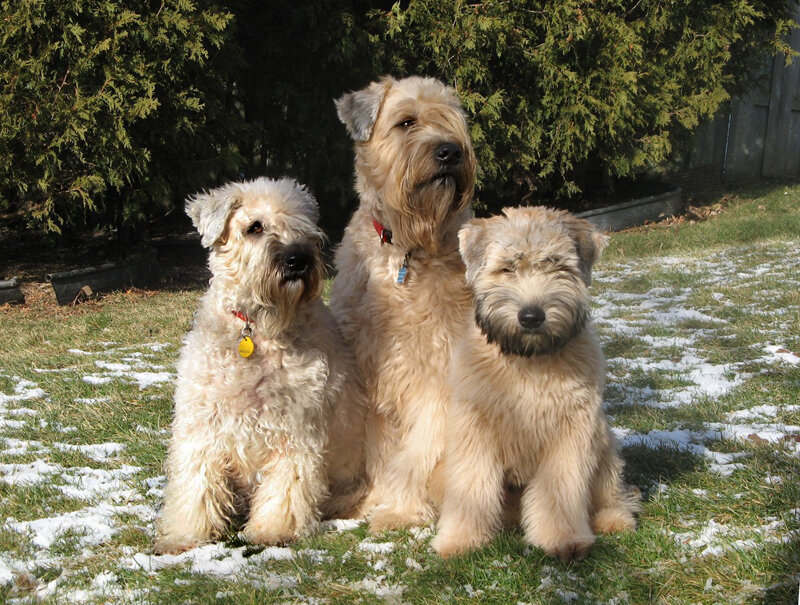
[0,0,791,239]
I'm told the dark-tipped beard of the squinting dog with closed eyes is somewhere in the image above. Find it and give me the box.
[475,296,589,357]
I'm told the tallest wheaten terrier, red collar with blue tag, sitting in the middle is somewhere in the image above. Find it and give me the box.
[331,77,475,531]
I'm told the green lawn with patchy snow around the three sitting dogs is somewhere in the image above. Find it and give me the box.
[0,185,800,604]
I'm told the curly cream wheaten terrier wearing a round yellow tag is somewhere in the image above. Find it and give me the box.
[155,179,365,552]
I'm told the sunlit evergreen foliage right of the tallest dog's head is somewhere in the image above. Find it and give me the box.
[380,0,792,210]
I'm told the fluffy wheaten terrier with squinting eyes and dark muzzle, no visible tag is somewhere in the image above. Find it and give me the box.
[433,208,639,559]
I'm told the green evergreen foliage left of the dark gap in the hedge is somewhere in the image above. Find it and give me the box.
[0,0,235,232]
